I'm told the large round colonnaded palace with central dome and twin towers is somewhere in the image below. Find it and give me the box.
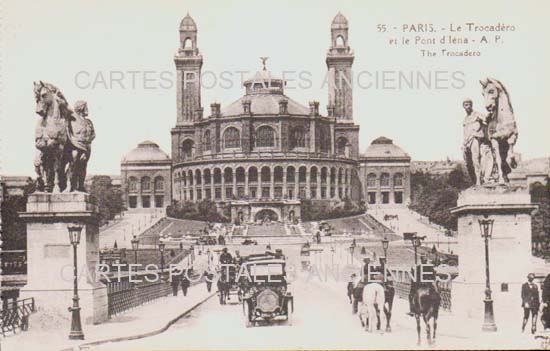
[171,14,361,223]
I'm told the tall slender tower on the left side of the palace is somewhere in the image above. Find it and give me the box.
[174,14,202,125]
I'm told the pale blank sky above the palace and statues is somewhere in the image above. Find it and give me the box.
[0,0,550,175]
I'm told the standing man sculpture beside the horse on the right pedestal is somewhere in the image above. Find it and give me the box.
[462,99,493,185]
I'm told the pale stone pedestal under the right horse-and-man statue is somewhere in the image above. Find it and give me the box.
[451,185,536,331]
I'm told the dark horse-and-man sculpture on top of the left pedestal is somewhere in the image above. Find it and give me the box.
[34,81,95,192]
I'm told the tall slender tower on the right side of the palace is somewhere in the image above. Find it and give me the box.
[326,12,355,122]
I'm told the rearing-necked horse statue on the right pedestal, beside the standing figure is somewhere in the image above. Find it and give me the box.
[480,78,518,184]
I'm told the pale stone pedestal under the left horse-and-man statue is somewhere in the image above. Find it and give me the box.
[19,192,108,326]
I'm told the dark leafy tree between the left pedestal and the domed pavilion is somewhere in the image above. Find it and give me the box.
[90,175,126,224]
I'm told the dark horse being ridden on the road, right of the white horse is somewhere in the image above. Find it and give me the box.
[412,284,441,345]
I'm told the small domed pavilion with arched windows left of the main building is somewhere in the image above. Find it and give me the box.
[120,141,172,209]
